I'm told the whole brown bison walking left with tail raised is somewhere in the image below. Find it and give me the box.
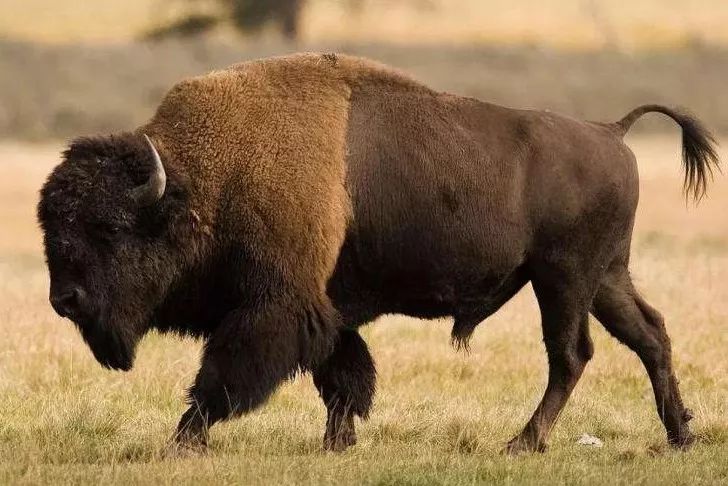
[38,54,718,453]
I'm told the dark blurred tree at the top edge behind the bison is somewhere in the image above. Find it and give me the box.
[143,0,305,40]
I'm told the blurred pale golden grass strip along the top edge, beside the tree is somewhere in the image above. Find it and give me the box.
[0,0,728,49]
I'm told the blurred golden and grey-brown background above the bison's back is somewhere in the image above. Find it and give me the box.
[0,0,728,141]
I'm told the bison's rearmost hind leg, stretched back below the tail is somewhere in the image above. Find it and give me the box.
[592,263,694,447]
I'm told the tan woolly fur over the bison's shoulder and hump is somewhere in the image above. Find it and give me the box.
[138,54,429,292]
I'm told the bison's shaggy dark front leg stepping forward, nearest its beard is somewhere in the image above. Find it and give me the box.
[175,297,339,448]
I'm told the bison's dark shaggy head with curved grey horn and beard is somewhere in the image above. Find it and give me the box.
[38,134,185,370]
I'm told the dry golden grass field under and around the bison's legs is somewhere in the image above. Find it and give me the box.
[0,136,728,484]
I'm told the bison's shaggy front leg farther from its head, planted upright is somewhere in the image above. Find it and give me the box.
[313,329,376,451]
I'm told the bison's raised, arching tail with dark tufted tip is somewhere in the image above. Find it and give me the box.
[616,105,720,201]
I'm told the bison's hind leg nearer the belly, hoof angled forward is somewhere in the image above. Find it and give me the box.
[506,279,594,454]
